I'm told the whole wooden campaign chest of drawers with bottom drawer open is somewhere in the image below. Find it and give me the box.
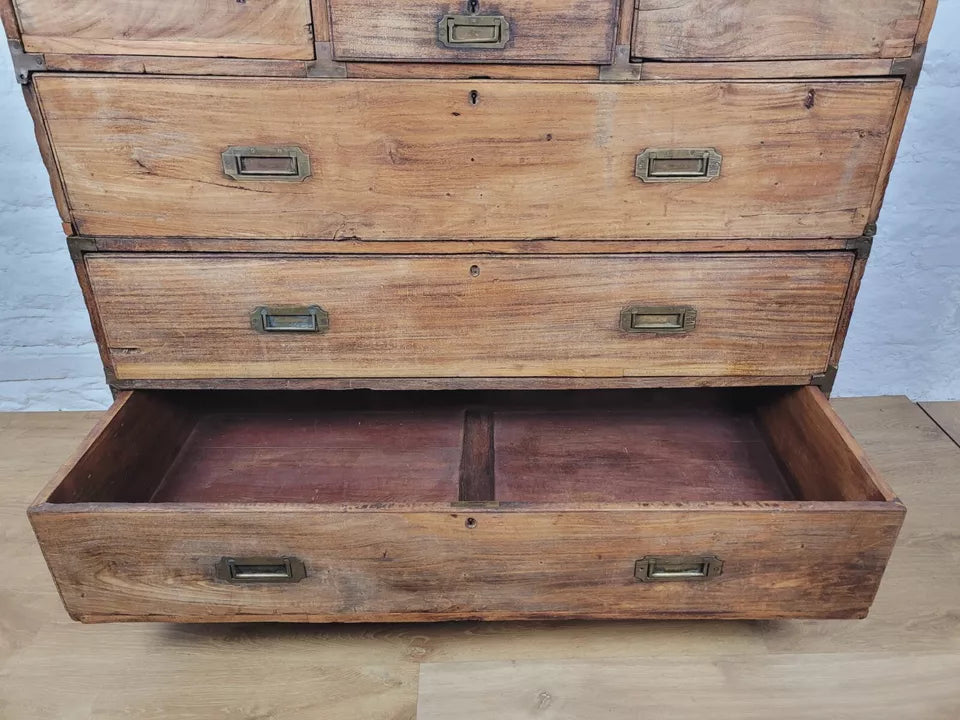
[0,0,936,622]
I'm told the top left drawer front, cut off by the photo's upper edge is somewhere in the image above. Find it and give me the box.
[13,0,313,60]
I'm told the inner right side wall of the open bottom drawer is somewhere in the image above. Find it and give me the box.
[758,386,896,501]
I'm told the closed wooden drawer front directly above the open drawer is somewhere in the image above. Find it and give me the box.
[85,252,853,380]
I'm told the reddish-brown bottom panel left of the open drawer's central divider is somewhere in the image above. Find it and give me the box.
[152,408,463,504]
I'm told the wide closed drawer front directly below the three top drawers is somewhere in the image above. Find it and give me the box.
[35,74,901,240]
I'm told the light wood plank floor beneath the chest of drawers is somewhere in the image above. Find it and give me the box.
[0,398,960,720]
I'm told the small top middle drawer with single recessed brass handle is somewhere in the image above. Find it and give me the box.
[330,0,619,65]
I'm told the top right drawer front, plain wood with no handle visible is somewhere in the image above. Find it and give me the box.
[633,0,923,60]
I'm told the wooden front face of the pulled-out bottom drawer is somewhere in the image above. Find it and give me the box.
[32,503,902,622]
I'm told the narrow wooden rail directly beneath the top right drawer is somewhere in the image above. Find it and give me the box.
[640,58,893,80]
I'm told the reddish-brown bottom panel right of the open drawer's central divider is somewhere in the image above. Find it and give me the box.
[494,398,794,502]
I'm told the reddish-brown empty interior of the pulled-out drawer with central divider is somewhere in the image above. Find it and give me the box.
[46,387,893,507]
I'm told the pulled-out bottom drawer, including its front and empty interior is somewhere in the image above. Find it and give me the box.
[30,387,904,622]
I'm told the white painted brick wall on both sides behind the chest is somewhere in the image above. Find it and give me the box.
[0,0,960,410]
